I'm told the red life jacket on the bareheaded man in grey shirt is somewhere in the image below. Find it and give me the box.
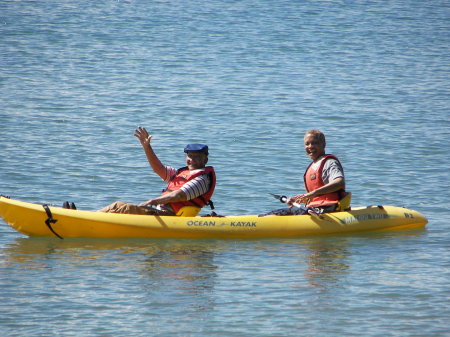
[303,154,345,207]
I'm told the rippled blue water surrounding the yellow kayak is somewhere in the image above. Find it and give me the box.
[0,0,450,336]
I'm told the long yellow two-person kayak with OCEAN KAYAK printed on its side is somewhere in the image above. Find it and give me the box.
[0,197,428,239]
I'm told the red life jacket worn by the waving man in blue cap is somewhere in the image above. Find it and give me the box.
[163,166,216,213]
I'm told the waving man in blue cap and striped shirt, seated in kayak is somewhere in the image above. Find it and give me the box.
[100,127,216,216]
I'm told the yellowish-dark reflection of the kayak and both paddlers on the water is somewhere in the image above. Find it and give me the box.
[0,228,426,293]
